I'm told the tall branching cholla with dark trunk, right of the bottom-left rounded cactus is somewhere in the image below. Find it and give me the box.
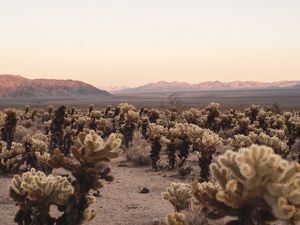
[49,131,122,225]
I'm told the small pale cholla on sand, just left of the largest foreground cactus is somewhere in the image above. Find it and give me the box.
[162,183,192,212]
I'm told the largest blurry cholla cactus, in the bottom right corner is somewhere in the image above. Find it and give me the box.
[192,145,300,225]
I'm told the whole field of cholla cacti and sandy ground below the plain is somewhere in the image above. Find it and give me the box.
[0,102,300,225]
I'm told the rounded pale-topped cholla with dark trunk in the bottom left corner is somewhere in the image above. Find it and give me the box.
[9,169,74,225]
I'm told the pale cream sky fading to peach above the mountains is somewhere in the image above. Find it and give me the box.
[0,0,300,87]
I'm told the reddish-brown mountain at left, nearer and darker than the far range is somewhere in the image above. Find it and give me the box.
[0,74,111,98]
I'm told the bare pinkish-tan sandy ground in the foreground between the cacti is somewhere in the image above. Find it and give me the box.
[91,159,184,225]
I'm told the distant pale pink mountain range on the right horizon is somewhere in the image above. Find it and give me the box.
[114,81,300,93]
